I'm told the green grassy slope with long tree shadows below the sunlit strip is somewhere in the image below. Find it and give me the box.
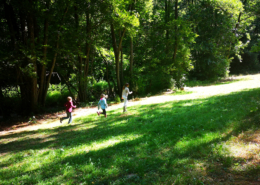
[0,89,260,185]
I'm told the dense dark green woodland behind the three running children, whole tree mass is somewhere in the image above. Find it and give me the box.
[0,0,260,116]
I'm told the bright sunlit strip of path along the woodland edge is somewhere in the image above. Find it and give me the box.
[3,74,260,136]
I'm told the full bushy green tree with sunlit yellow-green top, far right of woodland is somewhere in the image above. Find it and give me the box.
[190,1,248,80]
